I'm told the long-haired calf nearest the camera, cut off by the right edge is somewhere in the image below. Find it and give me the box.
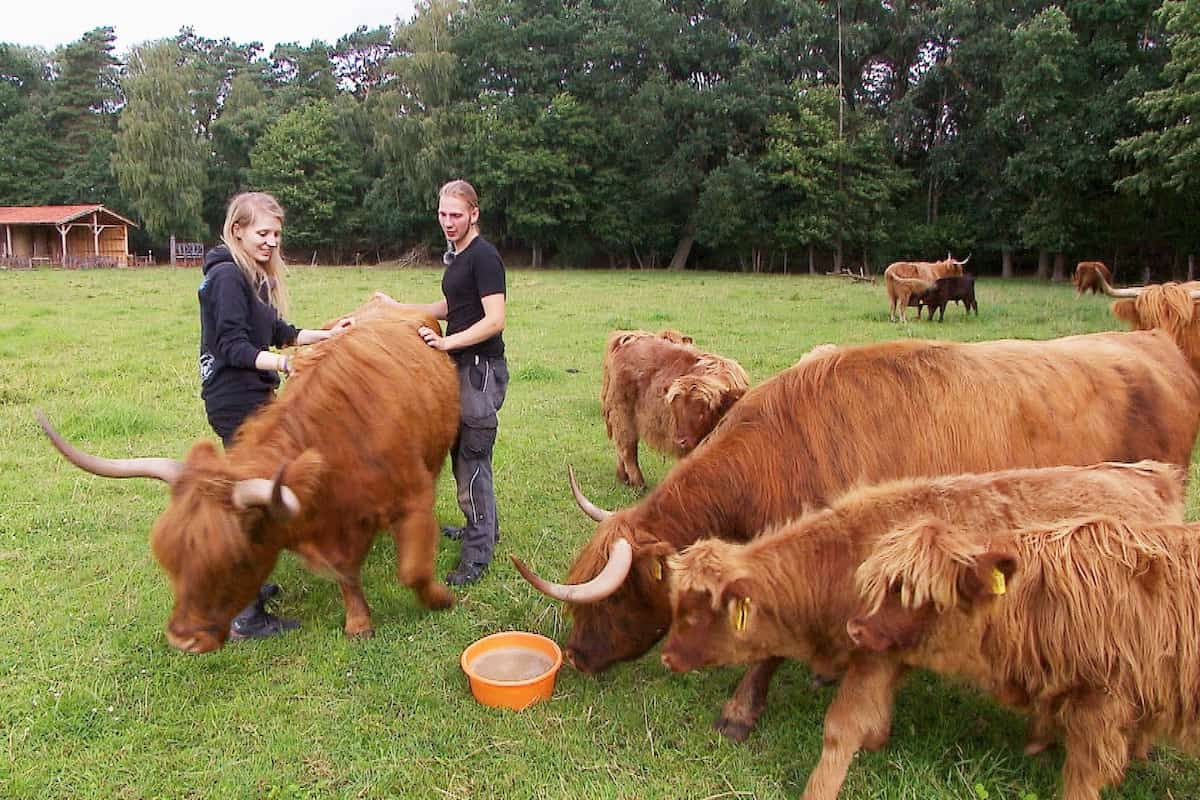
[847,510,1200,800]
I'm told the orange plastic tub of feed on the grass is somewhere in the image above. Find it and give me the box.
[460,631,563,711]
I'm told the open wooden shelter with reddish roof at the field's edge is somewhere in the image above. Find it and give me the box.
[0,205,137,267]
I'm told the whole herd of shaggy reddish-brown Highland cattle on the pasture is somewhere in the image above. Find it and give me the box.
[40,259,1200,800]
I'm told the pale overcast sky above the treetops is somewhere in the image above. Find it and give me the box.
[0,0,413,56]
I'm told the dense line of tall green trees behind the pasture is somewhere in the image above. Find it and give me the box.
[0,0,1200,281]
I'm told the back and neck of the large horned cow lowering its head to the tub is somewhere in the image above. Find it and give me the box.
[643,332,1200,541]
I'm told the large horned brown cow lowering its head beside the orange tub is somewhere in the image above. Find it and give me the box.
[517,331,1200,738]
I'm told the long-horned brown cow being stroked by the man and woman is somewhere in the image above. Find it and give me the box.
[41,311,458,652]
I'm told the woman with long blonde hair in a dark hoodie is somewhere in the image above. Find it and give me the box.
[199,192,354,638]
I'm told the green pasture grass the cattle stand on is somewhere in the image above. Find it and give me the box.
[0,267,1200,800]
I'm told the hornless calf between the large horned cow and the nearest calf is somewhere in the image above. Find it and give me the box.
[662,462,1183,800]
